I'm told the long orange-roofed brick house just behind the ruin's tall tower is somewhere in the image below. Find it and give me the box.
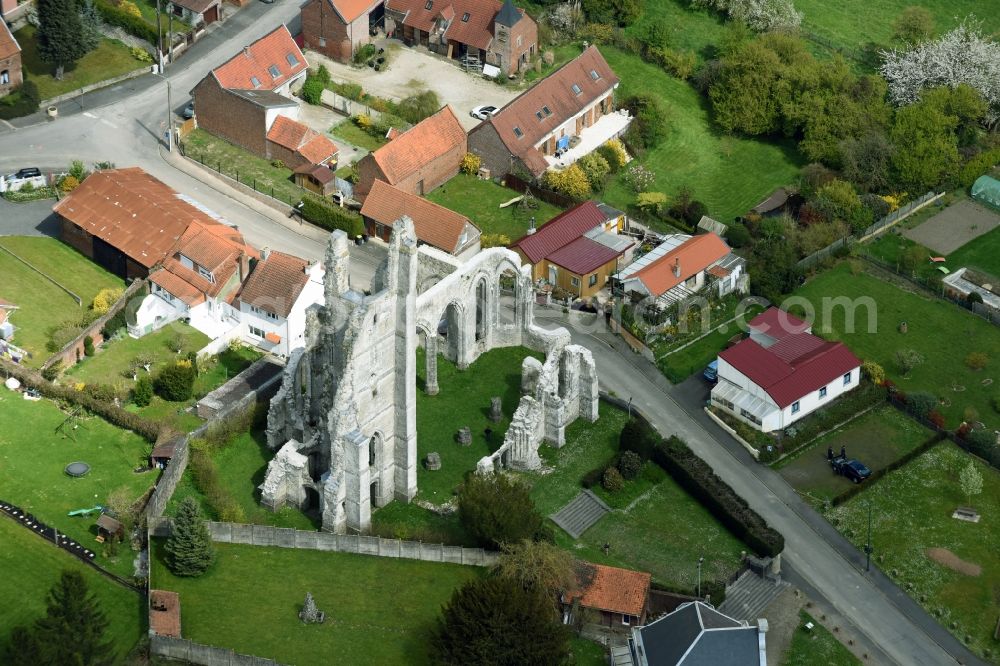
[361,180,481,258]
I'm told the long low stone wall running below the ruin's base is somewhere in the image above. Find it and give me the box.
[149,518,500,567]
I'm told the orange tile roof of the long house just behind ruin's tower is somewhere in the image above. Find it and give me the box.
[361,180,478,253]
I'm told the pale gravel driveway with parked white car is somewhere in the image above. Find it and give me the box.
[306,39,521,131]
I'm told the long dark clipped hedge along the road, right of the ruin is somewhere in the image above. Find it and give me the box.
[653,436,785,557]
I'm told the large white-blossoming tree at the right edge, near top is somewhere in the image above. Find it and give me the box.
[881,19,1000,124]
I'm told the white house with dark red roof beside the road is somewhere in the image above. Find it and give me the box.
[712,308,861,432]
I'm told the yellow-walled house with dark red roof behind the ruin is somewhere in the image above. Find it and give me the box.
[510,201,635,299]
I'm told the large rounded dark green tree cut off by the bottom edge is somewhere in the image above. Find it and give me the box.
[431,577,570,666]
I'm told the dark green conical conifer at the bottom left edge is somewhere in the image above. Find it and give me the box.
[34,571,115,666]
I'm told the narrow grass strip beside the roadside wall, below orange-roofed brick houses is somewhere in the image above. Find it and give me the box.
[184,129,305,204]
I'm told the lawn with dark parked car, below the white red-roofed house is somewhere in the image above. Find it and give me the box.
[775,405,934,507]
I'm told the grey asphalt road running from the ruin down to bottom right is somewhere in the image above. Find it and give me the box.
[536,310,984,666]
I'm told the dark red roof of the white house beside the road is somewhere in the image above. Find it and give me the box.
[719,308,861,409]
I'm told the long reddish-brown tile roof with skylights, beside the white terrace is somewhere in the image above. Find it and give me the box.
[484,46,618,161]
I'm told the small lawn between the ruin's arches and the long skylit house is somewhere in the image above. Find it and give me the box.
[427,173,562,241]
